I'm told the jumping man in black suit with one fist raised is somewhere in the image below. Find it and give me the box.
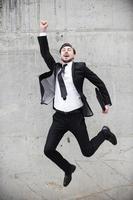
[38,20,117,186]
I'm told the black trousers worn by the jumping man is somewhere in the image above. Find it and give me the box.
[44,109,105,174]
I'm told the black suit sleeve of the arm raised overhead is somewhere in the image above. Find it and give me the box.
[38,36,56,71]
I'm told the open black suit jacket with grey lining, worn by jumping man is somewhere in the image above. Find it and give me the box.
[38,36,112,117]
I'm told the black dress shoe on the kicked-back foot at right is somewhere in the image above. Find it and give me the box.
[102,126,117,145]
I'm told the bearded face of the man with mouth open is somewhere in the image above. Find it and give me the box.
[61,46,75,63]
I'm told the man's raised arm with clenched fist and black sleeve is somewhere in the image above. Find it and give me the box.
[38,20,56,71]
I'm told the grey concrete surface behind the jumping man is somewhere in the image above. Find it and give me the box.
[0,0,133,200]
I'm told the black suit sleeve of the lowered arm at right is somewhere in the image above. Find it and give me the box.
[85,64,112,106]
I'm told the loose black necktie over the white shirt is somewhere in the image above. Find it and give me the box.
[58,64,67,100]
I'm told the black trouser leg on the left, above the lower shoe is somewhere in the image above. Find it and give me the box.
[44,113,71,173]
